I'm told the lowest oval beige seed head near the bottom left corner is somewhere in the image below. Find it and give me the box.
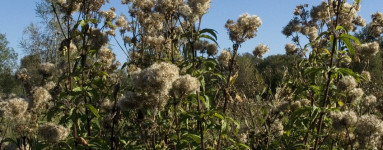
[38,123,69,143]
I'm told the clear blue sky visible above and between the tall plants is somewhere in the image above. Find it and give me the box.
[0,0,383,61]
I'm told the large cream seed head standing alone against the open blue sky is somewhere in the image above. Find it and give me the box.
[225,14,262,44]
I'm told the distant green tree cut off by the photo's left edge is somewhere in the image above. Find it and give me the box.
[0,33,17,94]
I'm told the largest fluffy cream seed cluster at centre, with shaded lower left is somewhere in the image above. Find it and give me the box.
[119,62,179,110]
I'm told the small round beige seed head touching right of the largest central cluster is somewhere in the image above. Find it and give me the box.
[173,74,200,97]
